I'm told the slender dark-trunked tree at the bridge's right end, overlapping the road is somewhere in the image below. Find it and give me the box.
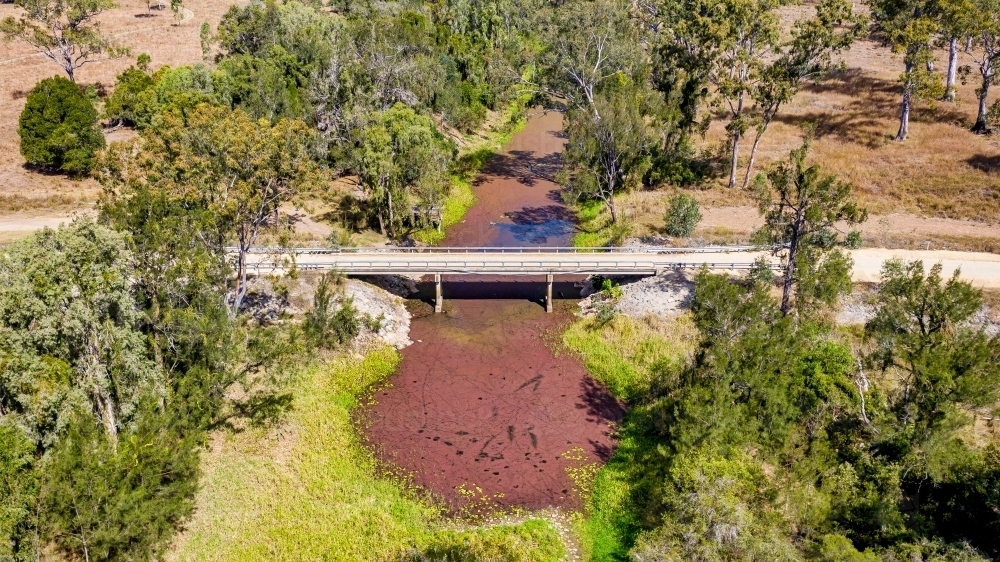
[754,133,868,314]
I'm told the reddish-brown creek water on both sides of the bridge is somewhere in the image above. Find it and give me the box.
[365,112,622,508]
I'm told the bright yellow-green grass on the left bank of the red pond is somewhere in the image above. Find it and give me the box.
[168,348,565,562]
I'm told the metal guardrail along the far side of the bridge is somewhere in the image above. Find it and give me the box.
[232,246,781,255]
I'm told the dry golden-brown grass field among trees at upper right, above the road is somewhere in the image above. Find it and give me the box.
[688,5,1000,223]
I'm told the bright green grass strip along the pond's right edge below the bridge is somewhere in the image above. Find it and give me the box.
[563,315,695,562]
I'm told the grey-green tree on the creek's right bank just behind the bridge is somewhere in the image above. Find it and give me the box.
[563,88,653,223]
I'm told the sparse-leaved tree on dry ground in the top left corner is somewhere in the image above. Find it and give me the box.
[0,0,128,82]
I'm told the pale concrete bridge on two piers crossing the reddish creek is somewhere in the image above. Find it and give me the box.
[247,246,781,312]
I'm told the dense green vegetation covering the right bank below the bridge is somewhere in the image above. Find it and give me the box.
[566,262,1000,562]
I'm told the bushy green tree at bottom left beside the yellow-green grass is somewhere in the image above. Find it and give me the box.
[38,408,201,561]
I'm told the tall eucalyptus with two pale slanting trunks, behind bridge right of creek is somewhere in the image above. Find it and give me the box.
[660,0,864,187]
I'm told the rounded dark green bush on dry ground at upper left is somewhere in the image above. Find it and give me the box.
[17,76,104,175]
